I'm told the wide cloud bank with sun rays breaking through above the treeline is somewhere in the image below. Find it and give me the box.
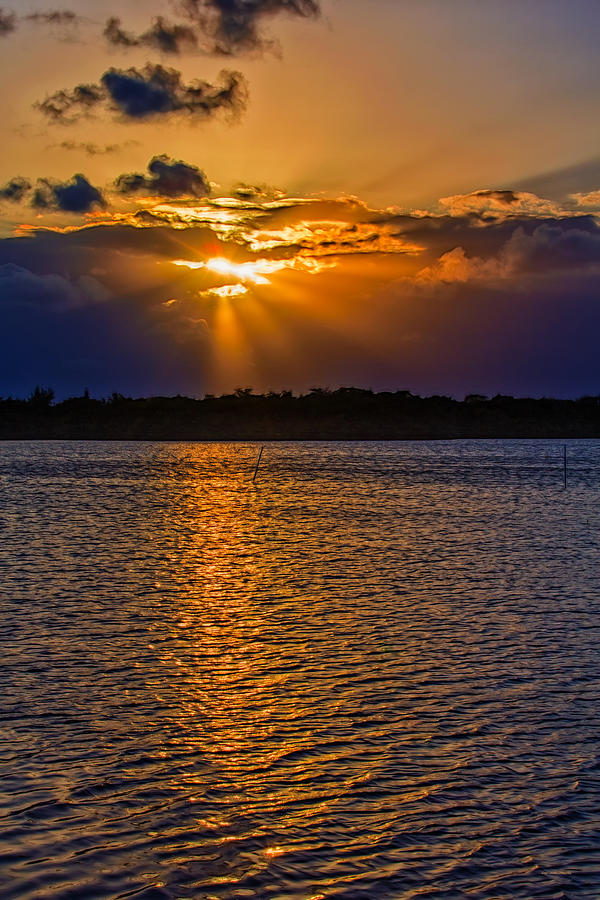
[0,179,600,396]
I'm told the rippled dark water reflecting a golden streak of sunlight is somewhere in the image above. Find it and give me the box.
[0,441,600,900]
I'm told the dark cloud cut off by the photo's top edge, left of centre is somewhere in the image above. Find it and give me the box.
[179,0,320,55]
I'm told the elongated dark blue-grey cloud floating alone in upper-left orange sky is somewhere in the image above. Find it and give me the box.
[35,63,247,124]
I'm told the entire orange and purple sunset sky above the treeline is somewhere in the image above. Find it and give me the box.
[0,0,600,398]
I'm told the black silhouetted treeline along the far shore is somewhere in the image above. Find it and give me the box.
[0,387,600,441]
